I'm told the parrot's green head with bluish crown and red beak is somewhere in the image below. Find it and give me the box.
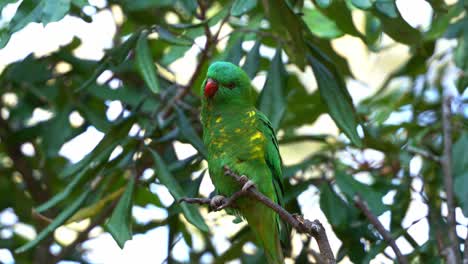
[202,61,252,105]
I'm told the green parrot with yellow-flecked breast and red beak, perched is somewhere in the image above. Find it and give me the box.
[201,61,288,264]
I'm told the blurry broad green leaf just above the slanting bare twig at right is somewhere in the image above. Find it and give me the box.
[335,170,387,216]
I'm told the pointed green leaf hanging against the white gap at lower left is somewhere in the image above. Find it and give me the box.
[106,176,135,248]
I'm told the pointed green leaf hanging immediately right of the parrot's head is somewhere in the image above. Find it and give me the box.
[257,48,287,131]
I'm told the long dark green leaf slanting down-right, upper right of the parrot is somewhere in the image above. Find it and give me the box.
[307,45,362,147]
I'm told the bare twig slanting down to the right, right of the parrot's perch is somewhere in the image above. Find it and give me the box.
[354,195,408,264]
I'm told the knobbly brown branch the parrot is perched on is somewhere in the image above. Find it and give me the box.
[179,166,336,264]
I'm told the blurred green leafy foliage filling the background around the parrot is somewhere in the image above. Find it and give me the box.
[0,0,468,263]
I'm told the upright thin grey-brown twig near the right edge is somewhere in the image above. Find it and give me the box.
[442,95,460,263]
